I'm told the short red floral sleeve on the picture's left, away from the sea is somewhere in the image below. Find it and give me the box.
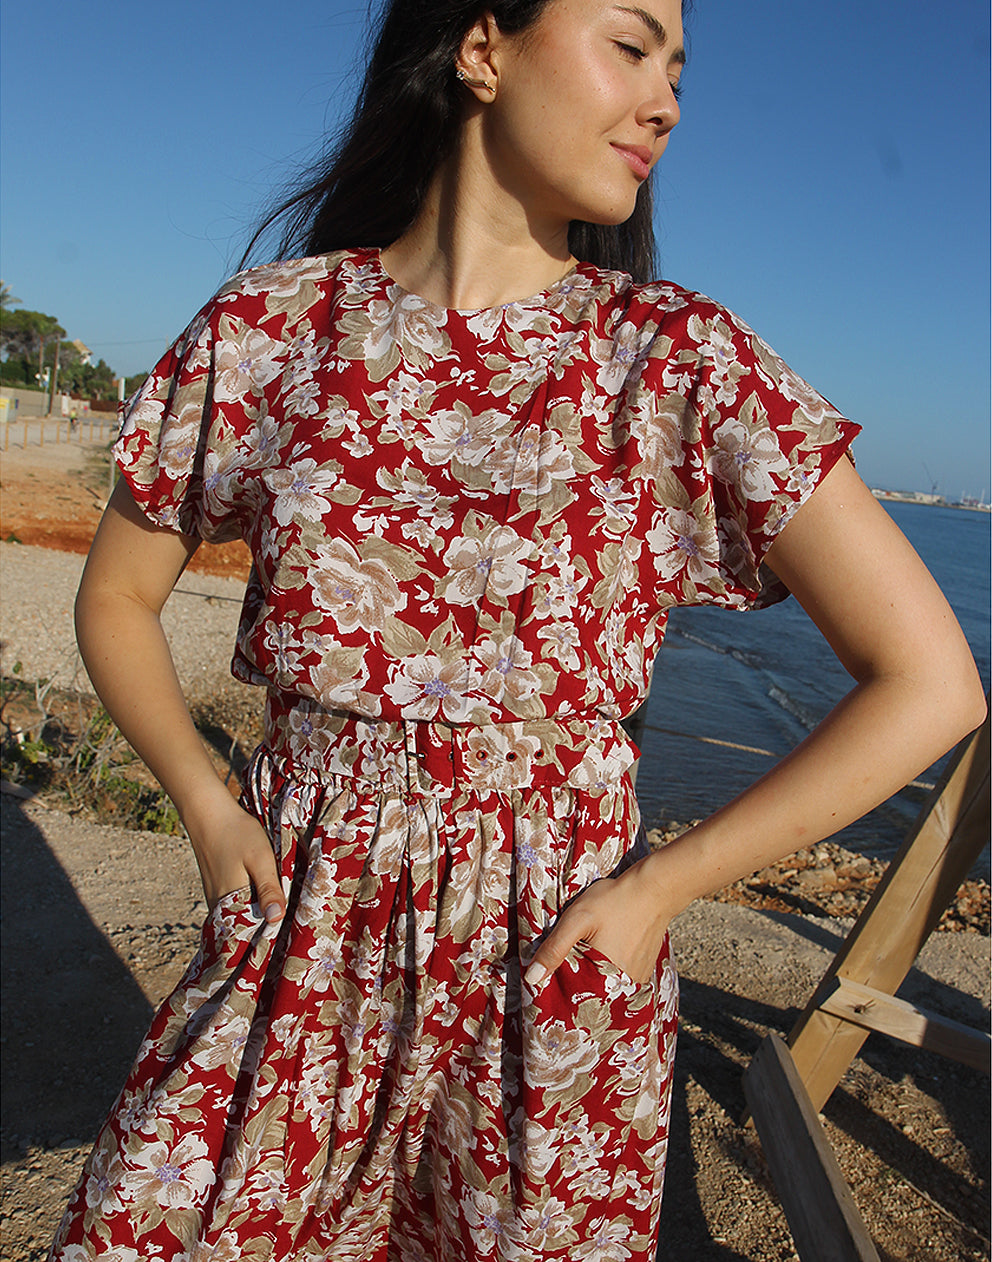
[114,286,253,543]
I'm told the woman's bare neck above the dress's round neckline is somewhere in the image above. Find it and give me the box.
[381,138,576,310]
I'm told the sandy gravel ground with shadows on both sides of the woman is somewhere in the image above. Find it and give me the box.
[0,527,989,1262]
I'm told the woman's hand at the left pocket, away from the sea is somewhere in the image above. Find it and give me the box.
[186,781,285,923]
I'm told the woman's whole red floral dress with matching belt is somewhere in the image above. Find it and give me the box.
[52,250,857,1262]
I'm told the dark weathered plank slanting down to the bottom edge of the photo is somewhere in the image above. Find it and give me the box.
[743,1034,878,1262]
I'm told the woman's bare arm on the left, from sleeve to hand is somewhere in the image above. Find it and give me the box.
[76,480,285,920]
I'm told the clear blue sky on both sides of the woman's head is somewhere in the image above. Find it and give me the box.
[0,0,992,498]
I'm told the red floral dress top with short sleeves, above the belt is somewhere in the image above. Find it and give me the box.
[108,250,857,724]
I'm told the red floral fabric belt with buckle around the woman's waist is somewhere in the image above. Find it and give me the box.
[265,692,640,794]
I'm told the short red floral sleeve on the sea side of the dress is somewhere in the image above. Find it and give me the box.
[633,295,861,608]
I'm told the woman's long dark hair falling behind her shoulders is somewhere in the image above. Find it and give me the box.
[241,0,686,280]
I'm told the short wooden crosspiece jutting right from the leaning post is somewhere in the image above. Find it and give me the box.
[820,977,992,1074]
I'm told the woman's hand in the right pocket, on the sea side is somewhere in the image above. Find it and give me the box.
[524,859,670,991]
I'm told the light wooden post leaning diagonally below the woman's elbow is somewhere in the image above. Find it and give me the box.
[789,719,989,1109]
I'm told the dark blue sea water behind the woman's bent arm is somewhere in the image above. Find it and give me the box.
[637,501,992,876]
